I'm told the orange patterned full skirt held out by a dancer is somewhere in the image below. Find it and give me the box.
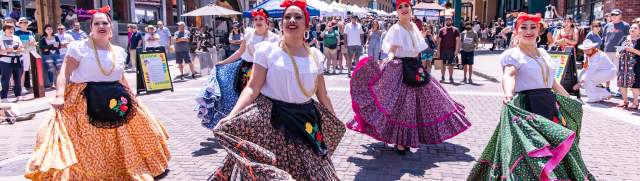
[25,83,170,180]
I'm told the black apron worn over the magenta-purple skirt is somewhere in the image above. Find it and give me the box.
[400,57,431,87]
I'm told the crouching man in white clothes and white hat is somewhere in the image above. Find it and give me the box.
[573,39,616,102]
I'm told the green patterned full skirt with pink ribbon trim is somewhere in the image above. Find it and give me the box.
[467,95,595,181]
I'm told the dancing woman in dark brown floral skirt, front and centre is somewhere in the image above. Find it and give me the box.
[213,0,345,180]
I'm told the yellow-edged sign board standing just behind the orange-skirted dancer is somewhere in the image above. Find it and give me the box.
[139,53,173,91]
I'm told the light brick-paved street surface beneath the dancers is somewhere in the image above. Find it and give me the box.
[0,55,640,181]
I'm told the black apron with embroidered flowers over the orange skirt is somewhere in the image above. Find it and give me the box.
[84,82,132,128]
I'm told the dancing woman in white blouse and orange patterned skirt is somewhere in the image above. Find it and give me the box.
[25,7,170,180]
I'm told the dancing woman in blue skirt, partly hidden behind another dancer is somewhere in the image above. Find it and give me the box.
[196,8,280,129]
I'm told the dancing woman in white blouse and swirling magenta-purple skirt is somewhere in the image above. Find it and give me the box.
[347,0,471,155]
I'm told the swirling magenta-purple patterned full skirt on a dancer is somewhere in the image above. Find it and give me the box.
[347,58,471,148]
